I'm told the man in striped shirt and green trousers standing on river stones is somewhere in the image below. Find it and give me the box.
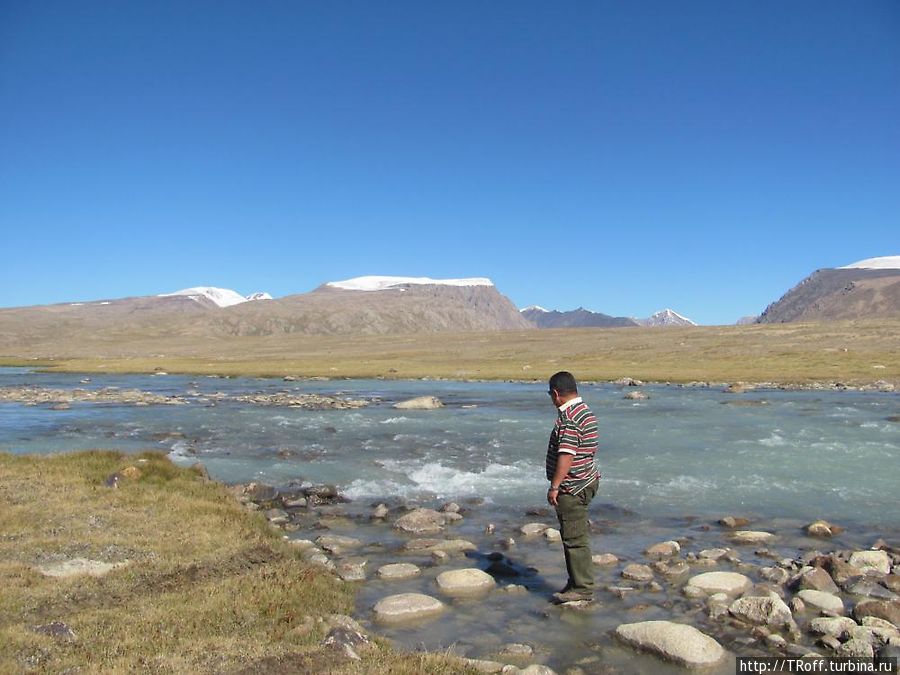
[546,371,600,603]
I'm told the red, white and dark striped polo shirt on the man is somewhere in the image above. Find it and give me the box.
[546,396,600,495]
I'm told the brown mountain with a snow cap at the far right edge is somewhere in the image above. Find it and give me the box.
[757,256,900,323]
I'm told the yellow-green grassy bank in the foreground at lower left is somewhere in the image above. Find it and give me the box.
[0,452,474,674]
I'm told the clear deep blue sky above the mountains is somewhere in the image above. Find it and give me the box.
[0,0,900,323]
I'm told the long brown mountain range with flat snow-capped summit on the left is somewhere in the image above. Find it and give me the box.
[0,277,532,346]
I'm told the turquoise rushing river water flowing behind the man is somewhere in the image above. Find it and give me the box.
[0,368,900,527]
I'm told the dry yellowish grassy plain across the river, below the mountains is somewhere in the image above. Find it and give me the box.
[0,320,900,384]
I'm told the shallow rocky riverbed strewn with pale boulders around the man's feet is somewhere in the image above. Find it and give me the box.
[232,482,900,673]
